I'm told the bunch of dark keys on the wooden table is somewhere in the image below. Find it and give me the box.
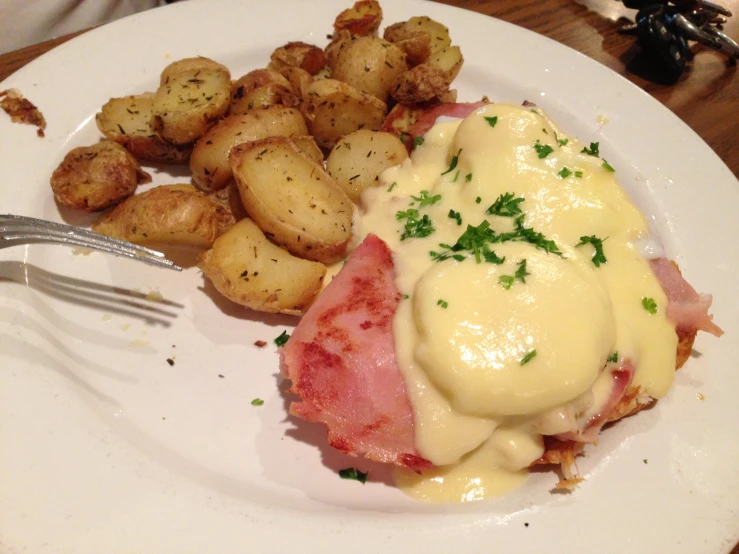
[621,0,739,75]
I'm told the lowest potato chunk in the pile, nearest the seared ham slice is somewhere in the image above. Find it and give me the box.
[198,219,326,315]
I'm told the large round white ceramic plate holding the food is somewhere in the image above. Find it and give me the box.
[0,0,739,553]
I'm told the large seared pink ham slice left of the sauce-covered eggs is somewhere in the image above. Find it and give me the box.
[280,235,431,471]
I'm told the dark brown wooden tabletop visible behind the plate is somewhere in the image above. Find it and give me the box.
[0,0,739,554]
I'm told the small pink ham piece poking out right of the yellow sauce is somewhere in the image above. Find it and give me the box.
[649,258,724,337]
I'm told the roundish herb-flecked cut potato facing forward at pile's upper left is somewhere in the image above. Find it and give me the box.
[153,68,231,144]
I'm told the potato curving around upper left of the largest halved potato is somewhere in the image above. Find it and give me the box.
[190,104,308,190]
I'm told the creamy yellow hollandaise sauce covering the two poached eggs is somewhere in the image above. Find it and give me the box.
[354,104,677,501]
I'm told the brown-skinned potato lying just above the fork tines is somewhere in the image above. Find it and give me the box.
[92,185,230,248]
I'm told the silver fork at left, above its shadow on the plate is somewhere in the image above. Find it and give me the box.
[0,214,182,271]
